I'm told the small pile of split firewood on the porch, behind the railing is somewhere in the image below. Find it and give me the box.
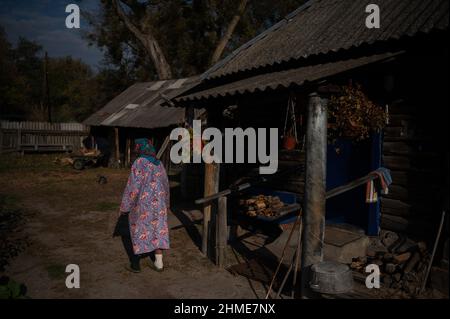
[239,195,285,217]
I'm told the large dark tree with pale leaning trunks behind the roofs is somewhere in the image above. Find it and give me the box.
[85,0,304,80]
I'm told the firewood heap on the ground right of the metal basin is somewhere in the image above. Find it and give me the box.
[350,234,430,296]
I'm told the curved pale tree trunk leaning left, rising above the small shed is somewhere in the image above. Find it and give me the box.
[113,0,172,80]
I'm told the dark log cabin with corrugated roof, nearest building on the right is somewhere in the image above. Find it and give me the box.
[173,0,449,248]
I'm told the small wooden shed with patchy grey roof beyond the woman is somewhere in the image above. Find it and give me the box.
[83,77,202,166]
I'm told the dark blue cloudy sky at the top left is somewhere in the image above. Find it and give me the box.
[0,0,102,70]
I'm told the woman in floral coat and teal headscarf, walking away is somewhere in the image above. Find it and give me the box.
[120,138,170,272]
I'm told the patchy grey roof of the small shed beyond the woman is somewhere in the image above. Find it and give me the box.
[83,77,199,128]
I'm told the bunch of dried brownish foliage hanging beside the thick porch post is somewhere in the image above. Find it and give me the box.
[328,84,386,142]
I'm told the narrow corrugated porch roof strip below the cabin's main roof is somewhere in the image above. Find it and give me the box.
[176,52,402,101]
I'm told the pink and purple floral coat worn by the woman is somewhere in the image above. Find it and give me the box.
[120,157,170,254]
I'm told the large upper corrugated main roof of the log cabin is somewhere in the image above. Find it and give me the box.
[206,0,449,79]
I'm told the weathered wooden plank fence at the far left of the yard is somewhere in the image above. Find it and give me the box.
[0,121,89,153]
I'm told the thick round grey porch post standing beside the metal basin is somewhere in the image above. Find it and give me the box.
[301,93,327,298]
